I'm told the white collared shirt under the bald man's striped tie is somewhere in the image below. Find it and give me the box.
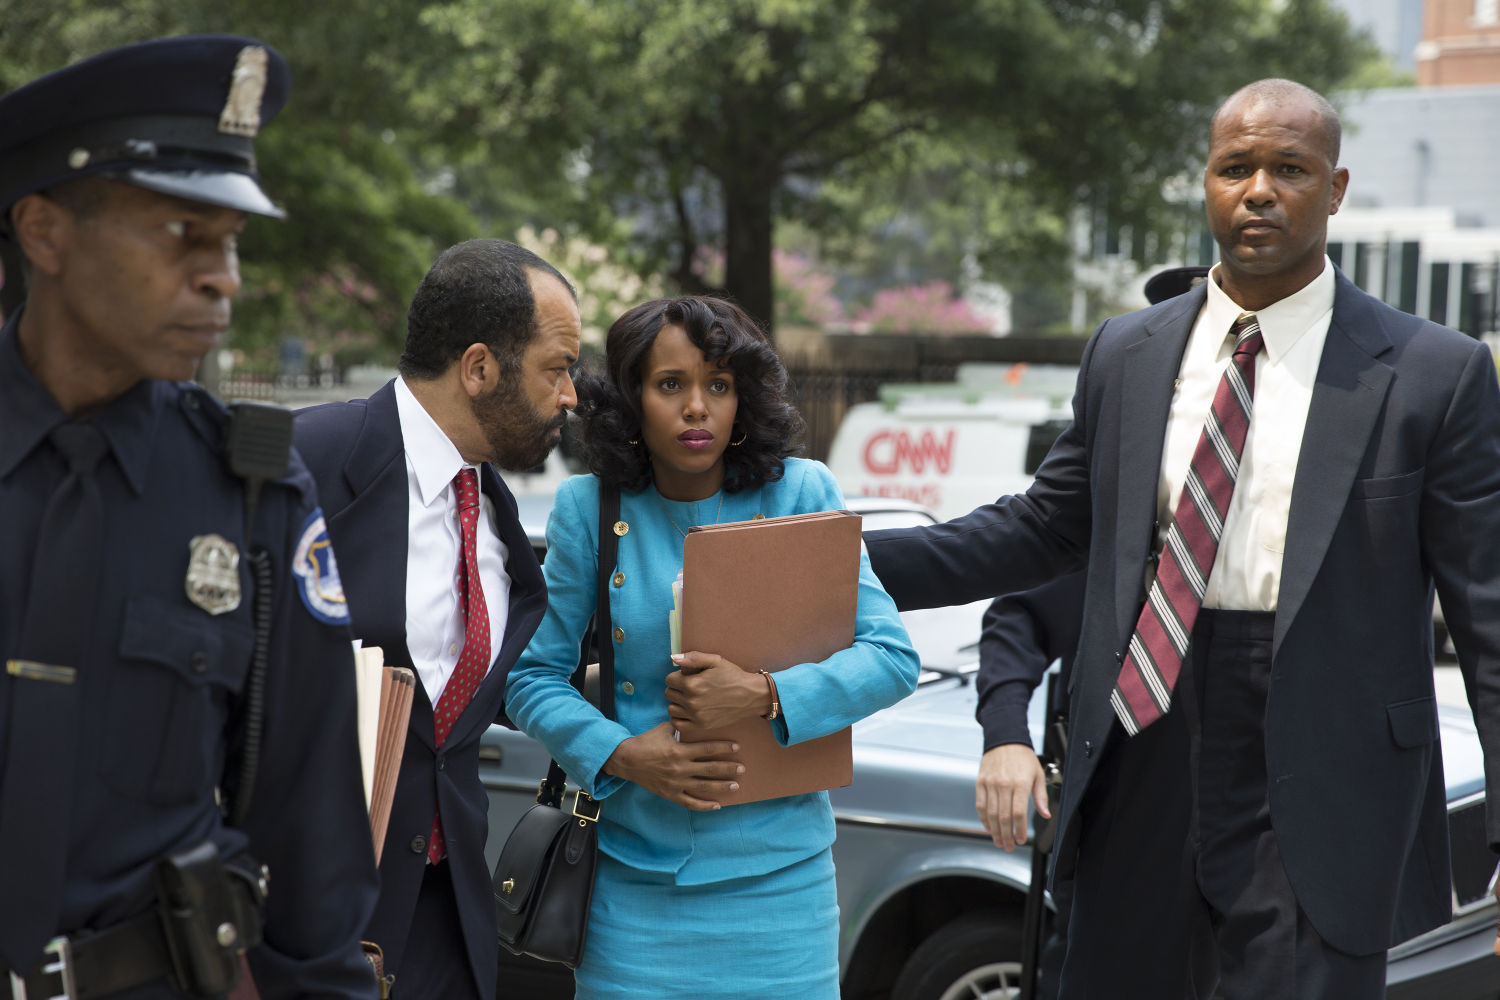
[1157,258,1334,612]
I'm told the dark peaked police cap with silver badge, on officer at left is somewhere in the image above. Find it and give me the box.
[0,34,291,219]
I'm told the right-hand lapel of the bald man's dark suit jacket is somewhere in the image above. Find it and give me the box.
[1274,273,1392,652]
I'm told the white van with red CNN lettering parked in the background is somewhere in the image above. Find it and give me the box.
[828,364,1077,520]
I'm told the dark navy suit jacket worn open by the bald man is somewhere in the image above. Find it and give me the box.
[866,274,1500,954]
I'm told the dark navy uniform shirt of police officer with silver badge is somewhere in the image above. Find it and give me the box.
[0,316,377,996]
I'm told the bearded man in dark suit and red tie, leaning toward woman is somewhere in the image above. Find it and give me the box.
[296,240,581,1000]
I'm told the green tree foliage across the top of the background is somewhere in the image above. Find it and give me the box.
[0,0,1374,352]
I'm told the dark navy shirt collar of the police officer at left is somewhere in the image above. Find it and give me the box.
[0,310,158,496]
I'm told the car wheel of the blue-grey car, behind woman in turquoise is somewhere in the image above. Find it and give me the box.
[891,910,1022,1000]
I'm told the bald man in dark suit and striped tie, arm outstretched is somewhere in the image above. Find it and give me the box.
[867,79,1500,1000]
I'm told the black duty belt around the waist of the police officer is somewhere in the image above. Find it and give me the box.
[0,871,264,1000]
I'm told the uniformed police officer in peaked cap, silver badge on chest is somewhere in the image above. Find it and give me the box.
[0,36,375,999]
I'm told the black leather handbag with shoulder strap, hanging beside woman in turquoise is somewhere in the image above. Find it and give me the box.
[492,486,620,969]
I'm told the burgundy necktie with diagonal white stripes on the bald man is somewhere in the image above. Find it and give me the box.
[1110,312,1263,736]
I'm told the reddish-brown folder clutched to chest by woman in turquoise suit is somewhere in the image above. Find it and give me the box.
[681,510,860,805]
